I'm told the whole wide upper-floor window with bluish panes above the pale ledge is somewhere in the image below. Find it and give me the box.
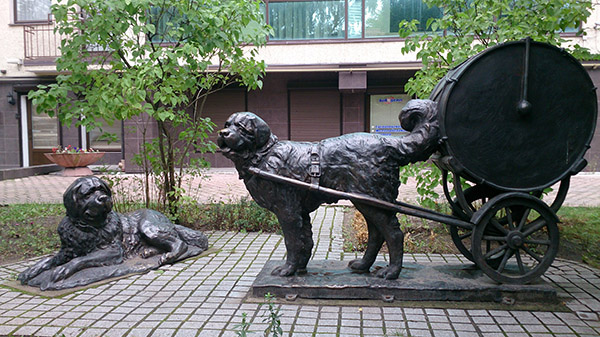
[264,0,442,40]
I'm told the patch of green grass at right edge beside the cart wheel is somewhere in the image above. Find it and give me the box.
[558,207,600,268]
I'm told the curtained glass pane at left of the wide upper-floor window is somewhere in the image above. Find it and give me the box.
[269,0,346,40]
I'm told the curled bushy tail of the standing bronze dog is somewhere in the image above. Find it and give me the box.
[397,99,440,166]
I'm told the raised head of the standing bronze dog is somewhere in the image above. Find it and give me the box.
[217,112,276,159]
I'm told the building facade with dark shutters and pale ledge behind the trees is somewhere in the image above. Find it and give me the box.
[0,0,600,171]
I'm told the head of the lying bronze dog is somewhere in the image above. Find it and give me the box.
[63,176,112,231]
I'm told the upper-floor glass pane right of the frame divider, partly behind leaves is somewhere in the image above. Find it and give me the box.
[365,0,442,37]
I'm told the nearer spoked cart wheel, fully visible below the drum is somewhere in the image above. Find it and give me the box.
[471,192,559,284]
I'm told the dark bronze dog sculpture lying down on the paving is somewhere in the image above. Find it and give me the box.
[18,176,208,290]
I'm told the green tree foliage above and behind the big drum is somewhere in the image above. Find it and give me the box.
[399,0,594,98]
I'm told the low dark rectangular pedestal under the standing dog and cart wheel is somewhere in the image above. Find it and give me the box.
[252,260,558,304]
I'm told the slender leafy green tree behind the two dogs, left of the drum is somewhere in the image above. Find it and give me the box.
[29,0,270,212]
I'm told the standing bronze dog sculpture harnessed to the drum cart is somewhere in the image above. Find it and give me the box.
[218,100,439,279]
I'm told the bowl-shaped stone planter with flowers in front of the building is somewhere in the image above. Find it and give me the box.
[44,145,104,176]
